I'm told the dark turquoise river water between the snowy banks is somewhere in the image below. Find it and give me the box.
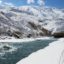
[0,40,54,64]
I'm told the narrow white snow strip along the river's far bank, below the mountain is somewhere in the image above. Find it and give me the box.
[0,37,53,43]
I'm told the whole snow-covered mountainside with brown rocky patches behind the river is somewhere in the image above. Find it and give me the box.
[0,6,64,38]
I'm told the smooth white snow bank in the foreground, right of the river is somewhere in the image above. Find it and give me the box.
[16,38,64,64]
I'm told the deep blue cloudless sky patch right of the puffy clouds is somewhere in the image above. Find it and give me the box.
[45,0,64,8]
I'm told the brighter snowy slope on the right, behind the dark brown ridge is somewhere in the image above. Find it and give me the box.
[20,6,64,33]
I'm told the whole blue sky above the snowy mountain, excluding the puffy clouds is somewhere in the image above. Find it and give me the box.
[0,0,64,8]
